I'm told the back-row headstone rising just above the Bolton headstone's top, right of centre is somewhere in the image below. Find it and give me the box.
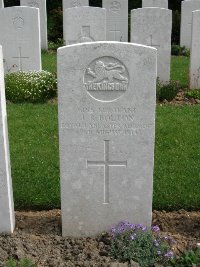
[102,0,128,42]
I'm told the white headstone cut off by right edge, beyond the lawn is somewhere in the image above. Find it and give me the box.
[190,10,200,89]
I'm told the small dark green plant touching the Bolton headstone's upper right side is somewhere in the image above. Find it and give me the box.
[156,80,181,101]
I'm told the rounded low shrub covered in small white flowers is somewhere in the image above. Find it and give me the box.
[5,71,57,103]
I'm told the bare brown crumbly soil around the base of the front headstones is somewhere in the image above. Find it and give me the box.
[0,210,200,267]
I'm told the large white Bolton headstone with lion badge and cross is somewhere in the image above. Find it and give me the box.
[58,42,157,239]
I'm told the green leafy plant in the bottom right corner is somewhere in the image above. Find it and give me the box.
[168,248,200,267]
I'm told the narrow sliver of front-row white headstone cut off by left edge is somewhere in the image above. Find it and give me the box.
[0,46,15,233]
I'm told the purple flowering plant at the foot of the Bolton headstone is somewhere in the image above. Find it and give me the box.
[111,221,174,267]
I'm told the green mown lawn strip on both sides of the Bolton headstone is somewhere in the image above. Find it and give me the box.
[7,104,200,210]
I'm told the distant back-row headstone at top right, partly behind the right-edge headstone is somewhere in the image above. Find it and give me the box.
[180,0,200,49]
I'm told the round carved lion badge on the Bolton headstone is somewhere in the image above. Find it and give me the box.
[84,57,129,102]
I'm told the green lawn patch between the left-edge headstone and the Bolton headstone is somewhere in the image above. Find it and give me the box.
[7,104,60,209]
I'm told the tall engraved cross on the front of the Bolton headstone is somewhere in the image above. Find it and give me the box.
[87,140,127,204]
